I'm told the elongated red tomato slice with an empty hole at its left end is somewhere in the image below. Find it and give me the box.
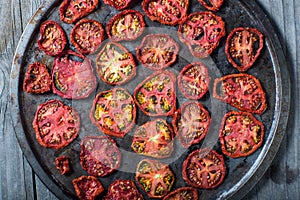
[213,74,267,114]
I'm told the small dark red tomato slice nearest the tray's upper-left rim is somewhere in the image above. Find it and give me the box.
[38,20,67,56]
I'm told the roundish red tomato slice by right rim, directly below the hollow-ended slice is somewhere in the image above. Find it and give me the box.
[220,111,264,158]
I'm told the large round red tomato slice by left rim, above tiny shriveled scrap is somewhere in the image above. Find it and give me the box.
[32,100,80,149]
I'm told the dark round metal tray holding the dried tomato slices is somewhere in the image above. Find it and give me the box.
[10,0,290,199]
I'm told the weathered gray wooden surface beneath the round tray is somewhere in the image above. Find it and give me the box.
[0,0,300,200]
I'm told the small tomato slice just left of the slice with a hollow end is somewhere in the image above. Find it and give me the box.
[177,62,210,100]
